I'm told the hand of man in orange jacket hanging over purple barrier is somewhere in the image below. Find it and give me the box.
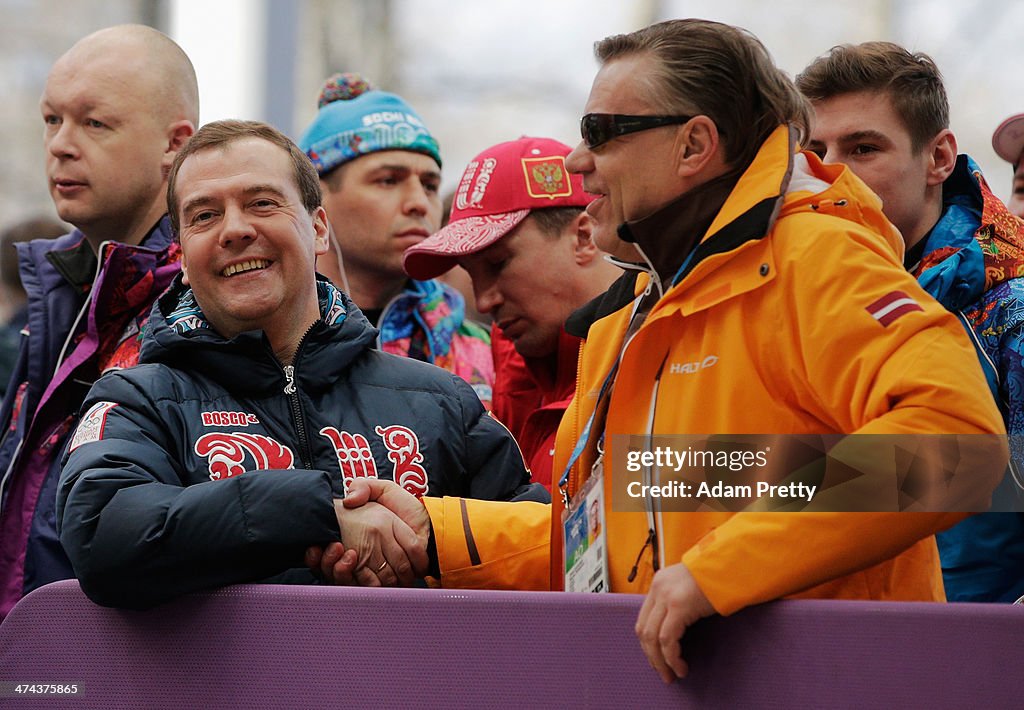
[636,562,715,683]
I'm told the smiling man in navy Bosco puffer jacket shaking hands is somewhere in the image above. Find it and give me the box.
[57,121,547,608]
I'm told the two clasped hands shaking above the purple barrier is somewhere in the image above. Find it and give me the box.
[305,478,430,587]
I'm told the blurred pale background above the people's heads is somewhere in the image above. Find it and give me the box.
[0,0,1024,224]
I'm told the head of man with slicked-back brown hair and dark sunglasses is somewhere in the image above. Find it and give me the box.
[566,19,810,251]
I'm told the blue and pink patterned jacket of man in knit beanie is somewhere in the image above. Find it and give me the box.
[378,280,495,410]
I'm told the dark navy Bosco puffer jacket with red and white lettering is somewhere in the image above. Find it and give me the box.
[57,279,547,608]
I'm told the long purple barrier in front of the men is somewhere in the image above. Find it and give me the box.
[0,581,1024,709]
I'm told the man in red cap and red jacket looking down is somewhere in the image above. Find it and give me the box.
[404,137,622,488]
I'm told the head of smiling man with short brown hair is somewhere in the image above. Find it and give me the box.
[168,121,328,364]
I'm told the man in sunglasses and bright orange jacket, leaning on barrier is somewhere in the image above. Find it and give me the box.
[309,19,1007,682]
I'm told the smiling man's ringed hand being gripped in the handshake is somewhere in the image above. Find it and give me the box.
[335,495,427,587]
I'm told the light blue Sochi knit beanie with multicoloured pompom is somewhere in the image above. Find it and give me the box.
[299,74,441,175]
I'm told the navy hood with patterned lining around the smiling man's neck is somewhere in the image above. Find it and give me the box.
[139,275,377,395]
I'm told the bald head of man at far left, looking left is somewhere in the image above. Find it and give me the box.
[40,25,199,245]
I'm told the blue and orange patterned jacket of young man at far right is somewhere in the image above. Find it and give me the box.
[914,155,1024,601]
